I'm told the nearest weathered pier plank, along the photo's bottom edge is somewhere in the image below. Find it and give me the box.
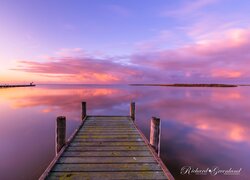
[48,171,167,180]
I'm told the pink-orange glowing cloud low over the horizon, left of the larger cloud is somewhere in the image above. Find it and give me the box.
[13,56,160,83]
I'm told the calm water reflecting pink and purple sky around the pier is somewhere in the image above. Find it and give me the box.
[0,85,250,180]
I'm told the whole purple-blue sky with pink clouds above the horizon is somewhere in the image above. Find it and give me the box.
[0,0,250,83]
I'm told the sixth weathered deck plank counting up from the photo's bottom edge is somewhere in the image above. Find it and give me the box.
[70,141,145,147]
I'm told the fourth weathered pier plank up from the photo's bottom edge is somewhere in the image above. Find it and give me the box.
[62,150,152,157]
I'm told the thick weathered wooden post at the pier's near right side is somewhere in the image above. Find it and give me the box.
[150,117,161,156]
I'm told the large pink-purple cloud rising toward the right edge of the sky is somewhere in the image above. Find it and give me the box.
[132,29,250,82]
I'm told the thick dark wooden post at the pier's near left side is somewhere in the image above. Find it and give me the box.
[56,116,66,153]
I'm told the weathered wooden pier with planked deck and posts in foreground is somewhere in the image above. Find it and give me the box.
[40,102,174,180]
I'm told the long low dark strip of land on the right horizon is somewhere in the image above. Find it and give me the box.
[129,84,238,87]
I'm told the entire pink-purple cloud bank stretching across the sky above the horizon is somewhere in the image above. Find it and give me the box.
[12,29,250,83]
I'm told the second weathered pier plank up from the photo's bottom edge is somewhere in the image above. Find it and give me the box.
[52,163,161,172]
